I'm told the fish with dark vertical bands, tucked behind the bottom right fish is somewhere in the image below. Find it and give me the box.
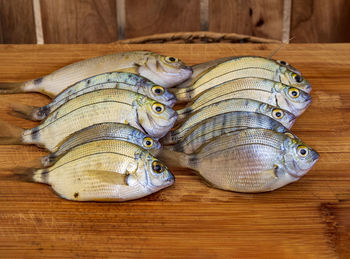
[162,111,296,154]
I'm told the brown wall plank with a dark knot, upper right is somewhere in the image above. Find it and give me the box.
[209,0,283,40]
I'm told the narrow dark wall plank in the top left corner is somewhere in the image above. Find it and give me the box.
[0,0,36,44]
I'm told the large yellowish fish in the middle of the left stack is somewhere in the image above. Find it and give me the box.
[0,89,177,152]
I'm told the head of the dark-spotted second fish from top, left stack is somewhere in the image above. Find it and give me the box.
[143,84,176,107]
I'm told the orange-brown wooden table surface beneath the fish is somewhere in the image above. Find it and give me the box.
[0,44,350,258]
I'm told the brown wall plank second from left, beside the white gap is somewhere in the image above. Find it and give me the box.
[41,0,117,43]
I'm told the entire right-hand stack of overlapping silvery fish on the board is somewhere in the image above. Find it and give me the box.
[157,56,319,193]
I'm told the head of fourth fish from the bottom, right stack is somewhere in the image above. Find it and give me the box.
[274,83,312,116]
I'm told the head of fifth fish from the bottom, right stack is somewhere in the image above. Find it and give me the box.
[279,66,312,93]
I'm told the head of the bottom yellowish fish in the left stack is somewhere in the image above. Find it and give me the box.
[144,153,175,191]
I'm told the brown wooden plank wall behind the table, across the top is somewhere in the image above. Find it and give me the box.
[0,0,350,44]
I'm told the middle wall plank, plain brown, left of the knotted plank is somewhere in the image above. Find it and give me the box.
[125,0,200,38]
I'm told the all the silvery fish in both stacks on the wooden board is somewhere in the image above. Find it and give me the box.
[0,51,319,201]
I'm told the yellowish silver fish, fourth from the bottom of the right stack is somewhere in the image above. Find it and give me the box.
[177,78,311,120]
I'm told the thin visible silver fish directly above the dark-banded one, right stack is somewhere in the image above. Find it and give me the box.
[161,98,296,144]
